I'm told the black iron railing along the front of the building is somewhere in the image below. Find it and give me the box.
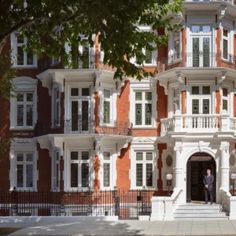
[0,190,153,219]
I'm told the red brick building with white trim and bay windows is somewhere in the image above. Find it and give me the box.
[0,1,236,219]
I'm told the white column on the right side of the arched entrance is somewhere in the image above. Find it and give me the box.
[220,142,229,191]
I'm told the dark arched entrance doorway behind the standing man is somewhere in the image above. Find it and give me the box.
[187,153,216,202]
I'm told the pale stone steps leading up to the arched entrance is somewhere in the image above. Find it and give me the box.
[174,203,228,220]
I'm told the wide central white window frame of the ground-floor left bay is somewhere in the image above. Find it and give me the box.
[66,149,93,191]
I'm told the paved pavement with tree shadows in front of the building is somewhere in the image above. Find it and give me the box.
[0,216,236,236]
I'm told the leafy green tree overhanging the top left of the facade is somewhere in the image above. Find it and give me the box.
[0,0,182,79]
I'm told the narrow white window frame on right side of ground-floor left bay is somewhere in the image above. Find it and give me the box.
[99,148,117,190]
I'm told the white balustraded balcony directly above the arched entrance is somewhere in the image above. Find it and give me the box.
[161,113,236,136]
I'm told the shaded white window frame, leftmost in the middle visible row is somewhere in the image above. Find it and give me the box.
[10,77,38,130]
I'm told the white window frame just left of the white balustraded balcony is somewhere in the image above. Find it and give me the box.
[130,80,157,129]
